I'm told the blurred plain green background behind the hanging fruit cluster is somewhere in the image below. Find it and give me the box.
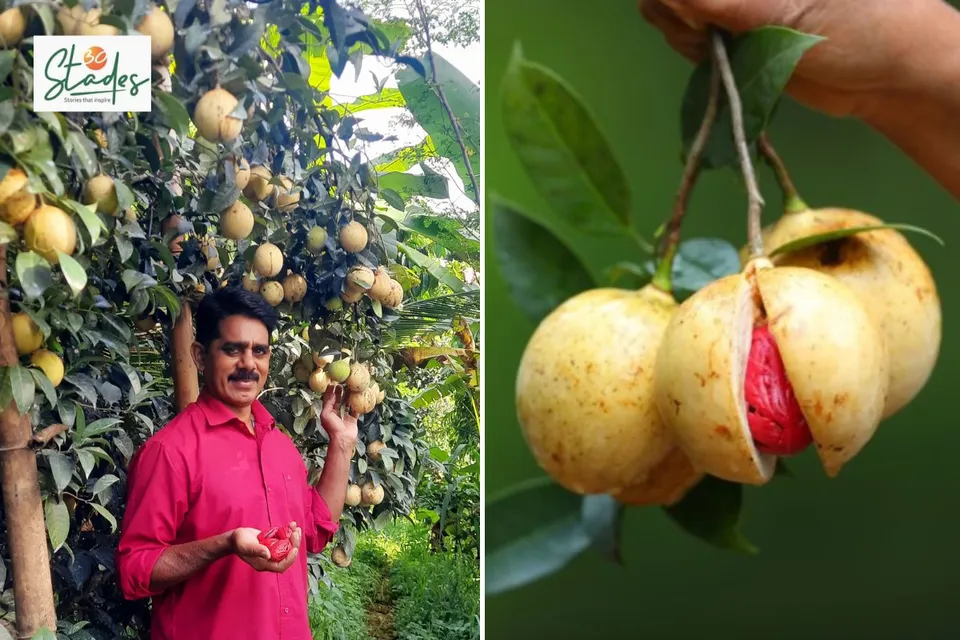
[484,0,960,640]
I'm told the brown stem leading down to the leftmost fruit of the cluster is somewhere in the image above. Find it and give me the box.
[652,55,720,293]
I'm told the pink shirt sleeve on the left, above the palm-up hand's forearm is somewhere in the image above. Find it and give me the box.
[117,441,188,600]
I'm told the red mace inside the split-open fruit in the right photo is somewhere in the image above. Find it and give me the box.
[743,326,813,456]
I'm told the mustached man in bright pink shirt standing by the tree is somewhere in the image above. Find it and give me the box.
[117,287,357,640]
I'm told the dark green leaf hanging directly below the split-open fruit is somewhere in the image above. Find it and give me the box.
[664,475,759,555]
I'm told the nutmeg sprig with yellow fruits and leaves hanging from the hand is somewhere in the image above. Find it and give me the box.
[486,27,941,594]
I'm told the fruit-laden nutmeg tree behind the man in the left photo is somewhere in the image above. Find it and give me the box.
[0,0,462,638]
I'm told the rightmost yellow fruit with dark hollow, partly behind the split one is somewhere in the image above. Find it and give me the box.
[763,208,942,419]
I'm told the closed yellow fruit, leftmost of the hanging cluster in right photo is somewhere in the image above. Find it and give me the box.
[515,285,702,505]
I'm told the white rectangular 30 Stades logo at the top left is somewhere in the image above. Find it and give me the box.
[33,35,152,112]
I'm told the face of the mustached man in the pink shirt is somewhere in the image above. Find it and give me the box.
[195,315,270,408]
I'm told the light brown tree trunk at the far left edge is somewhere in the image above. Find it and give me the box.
[0,245,57,638]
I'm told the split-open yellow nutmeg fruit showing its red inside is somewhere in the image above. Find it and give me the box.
[653,258,890,485]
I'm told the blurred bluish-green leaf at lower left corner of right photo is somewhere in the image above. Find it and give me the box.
[484,478,591,596]
